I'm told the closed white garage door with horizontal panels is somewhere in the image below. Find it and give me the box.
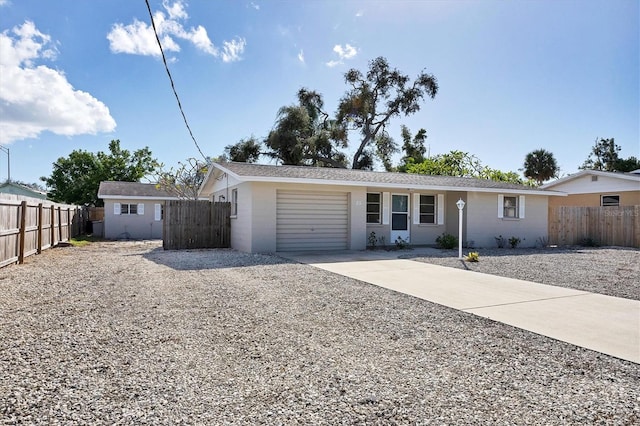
[276,191,349,251]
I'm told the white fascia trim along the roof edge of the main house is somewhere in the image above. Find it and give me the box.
[207,163,568,197]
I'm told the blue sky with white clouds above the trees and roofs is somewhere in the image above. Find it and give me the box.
[0,0,640,186]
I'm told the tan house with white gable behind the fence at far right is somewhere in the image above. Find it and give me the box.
[540,170,640,207]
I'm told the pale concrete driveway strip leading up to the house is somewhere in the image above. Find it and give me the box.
[278,251,640,363]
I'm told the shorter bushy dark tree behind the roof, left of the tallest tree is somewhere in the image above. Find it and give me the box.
[264,88,347,167]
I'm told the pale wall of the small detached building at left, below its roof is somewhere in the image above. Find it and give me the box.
[104,199,164,240]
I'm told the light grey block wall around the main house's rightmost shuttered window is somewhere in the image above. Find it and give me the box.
[463,192,548,247]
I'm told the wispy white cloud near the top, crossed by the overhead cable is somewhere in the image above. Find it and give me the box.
[107,0,246,62]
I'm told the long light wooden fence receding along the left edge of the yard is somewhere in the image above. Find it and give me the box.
[0,199,87,268]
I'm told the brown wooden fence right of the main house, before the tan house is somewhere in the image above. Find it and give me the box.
[549,206,640,248]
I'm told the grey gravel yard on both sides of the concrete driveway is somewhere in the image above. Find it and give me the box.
[0,242,640,425]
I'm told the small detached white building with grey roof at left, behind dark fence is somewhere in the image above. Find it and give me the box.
[98,181,178,240]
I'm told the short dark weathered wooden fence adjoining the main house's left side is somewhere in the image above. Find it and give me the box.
[162,200,231,250]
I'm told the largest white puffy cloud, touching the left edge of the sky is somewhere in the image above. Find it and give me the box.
[0,21,116,143]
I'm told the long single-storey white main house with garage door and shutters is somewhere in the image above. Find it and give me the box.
[200,163,564,252]
